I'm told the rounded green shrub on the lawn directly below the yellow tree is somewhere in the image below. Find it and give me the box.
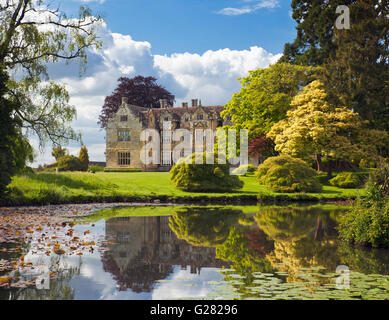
[255,155,323,192]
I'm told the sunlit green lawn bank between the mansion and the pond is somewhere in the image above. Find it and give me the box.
[2,172,363,205]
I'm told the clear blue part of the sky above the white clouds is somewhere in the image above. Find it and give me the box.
[66,0,295,54]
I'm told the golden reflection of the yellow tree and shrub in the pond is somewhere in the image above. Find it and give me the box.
[255,207,341,282]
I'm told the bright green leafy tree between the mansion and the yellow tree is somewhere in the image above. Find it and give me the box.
[222,63,318,136]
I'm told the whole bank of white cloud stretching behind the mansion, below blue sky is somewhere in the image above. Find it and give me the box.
[33,25,280,163]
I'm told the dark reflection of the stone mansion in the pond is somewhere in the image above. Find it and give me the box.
[103,217,229,292]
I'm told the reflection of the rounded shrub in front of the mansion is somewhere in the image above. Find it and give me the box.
[169,207,243,247]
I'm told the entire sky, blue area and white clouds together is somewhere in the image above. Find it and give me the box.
[31,0,296,167]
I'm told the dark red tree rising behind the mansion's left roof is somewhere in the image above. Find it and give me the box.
[98,76,174,128]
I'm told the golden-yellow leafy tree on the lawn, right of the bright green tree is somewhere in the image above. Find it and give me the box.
[267,80,388,175]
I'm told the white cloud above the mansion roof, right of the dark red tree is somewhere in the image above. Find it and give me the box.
[154,47,280,104]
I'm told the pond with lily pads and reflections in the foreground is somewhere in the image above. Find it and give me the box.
[0,205,389,300]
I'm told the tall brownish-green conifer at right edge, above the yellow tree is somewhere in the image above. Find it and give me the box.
[323,0,389,130]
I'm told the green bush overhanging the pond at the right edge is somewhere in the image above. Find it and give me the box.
[339,201,389,247]
